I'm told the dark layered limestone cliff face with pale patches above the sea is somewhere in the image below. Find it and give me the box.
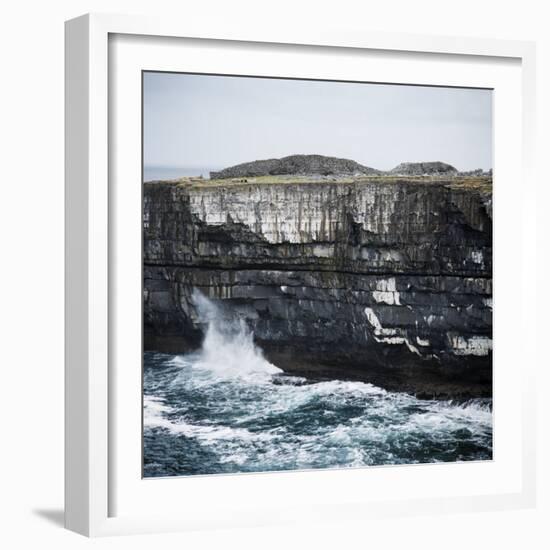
[144,178,492,396]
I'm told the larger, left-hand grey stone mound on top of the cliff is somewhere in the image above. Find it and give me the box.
[210,155,380,179]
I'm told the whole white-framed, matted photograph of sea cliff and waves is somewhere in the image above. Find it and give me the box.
[66,15,536,536]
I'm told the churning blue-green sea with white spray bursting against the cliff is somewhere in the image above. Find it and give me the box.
[143,297,493,477]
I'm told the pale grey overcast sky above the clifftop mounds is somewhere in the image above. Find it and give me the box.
[143,72,492,170]
